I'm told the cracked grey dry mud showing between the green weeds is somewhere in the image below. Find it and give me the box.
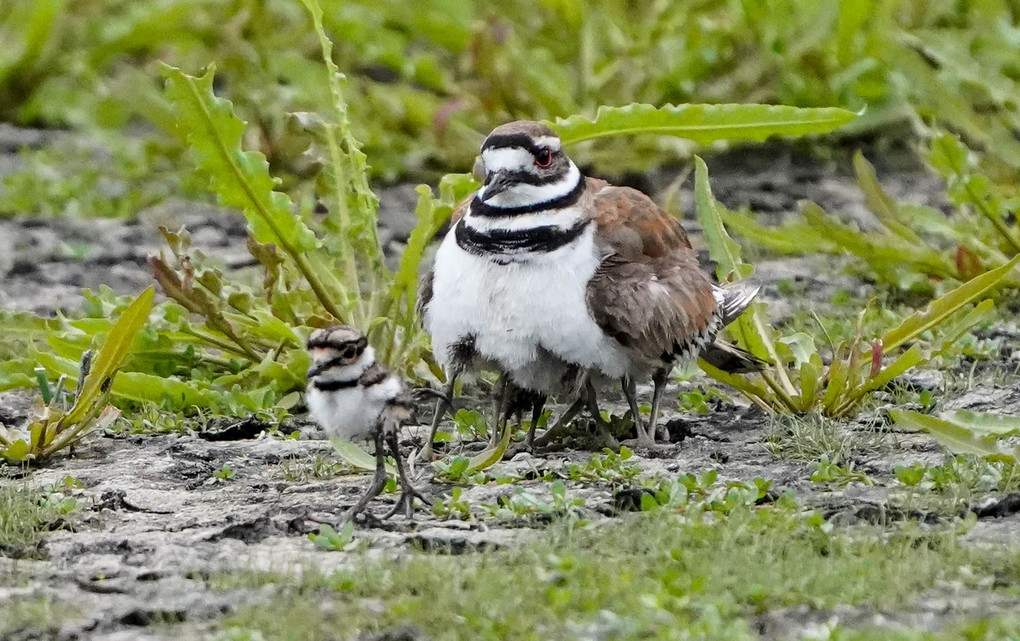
[0,131,1020,640]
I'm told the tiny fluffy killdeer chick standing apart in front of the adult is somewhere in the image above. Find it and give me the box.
[306,326,430,522]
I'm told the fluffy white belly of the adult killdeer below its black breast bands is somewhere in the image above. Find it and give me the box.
[425,226,627,392]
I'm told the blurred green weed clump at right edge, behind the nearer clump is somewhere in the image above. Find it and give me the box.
[723,133,1020,296]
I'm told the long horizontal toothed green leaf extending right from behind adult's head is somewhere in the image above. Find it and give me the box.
[547,103,857,144]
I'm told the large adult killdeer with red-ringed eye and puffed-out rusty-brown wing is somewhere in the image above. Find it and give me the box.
[421,121,760,446]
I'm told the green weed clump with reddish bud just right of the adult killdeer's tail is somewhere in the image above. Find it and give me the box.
[695,158,1020,417]
